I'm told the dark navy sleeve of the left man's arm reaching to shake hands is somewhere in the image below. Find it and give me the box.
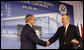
[28,29,46,46]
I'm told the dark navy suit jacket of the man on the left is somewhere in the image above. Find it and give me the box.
[21,24,46,49]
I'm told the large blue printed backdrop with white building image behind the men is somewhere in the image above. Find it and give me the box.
[1,1,74,49]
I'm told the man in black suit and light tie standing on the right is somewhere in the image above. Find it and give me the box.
[47,14,80,49]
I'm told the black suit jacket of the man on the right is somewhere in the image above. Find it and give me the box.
[49,24,80,49]
